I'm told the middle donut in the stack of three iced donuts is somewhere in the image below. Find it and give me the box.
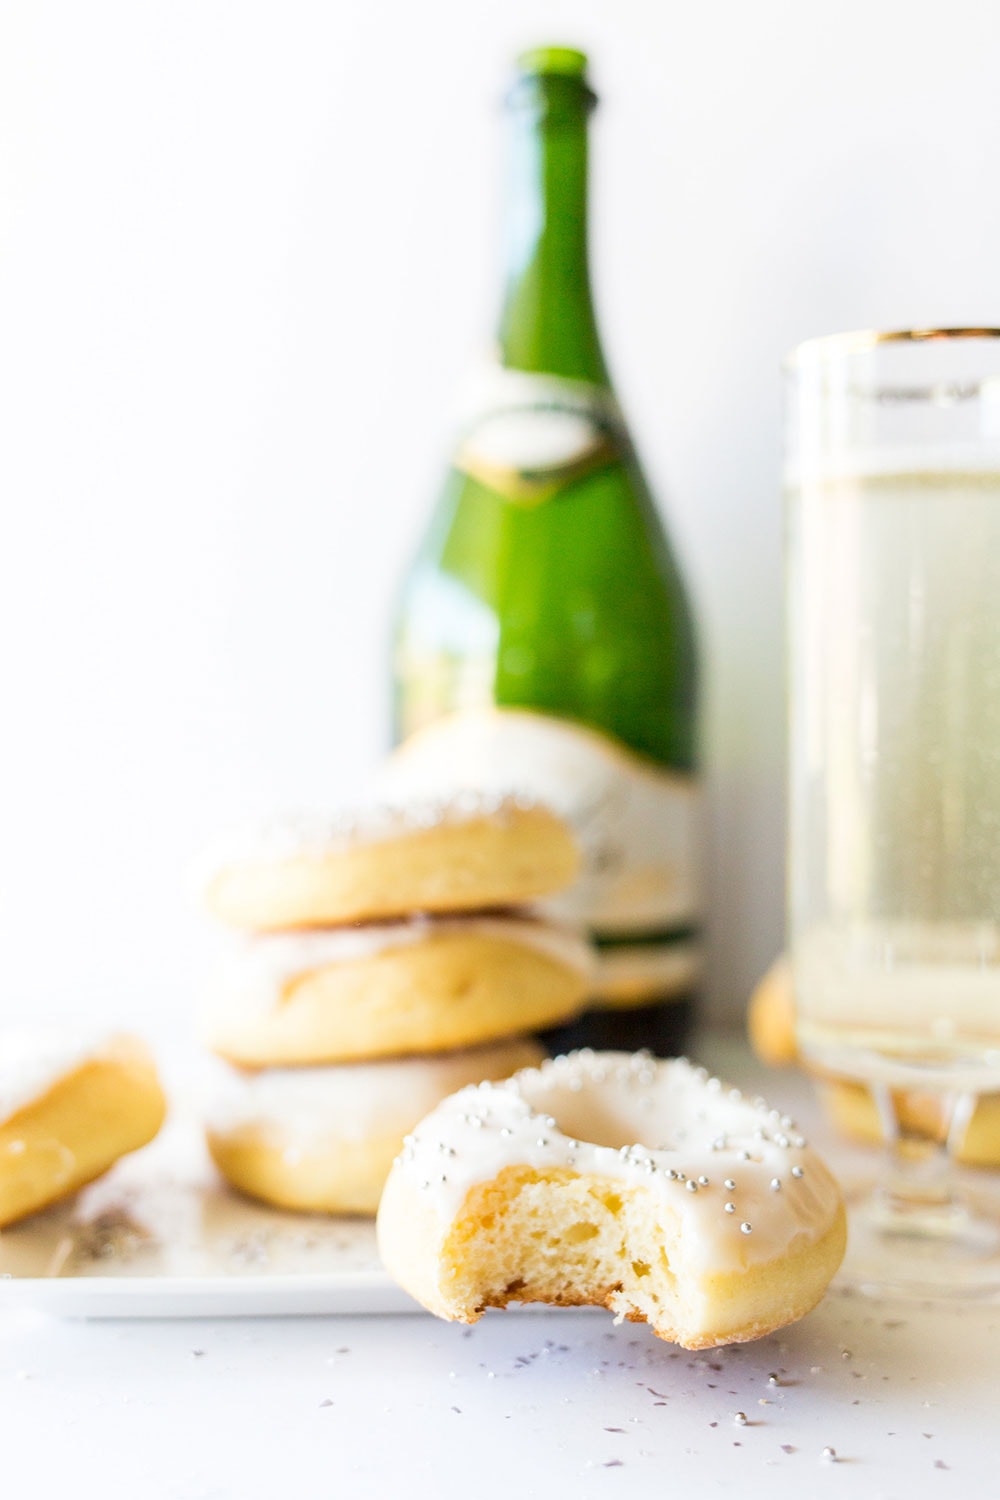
[201,915,589,1068]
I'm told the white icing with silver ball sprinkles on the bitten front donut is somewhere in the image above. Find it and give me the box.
[393,1052,840,1274]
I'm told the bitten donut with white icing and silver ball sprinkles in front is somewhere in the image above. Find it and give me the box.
[378,1052,846,1349]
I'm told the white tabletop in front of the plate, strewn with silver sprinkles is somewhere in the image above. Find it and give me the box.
[0,1038,1000,1500]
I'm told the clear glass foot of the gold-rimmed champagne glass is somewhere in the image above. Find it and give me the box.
[838,1176,1000,1302]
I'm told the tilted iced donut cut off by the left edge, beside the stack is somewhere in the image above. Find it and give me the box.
[0,1032,166,1227]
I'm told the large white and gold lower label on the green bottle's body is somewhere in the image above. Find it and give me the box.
[378,708,702,1005]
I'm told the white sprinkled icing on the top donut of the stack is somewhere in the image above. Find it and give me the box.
[192,789,548,893]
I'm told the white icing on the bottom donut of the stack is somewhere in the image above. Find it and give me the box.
[204,1041,542,1149]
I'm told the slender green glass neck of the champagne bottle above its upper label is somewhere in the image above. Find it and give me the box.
[499,77,607,386]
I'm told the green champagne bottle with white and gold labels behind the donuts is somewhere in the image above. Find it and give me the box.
[390,48,700,1055]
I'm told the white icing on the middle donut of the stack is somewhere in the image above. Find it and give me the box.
[203,917,592,1017]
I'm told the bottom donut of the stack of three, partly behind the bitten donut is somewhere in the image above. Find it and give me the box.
[205,1040,543,1214]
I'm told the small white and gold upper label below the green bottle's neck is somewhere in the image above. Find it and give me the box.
[454,365,624,506]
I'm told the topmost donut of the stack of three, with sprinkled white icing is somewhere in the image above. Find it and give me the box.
[198,794,580,932]
